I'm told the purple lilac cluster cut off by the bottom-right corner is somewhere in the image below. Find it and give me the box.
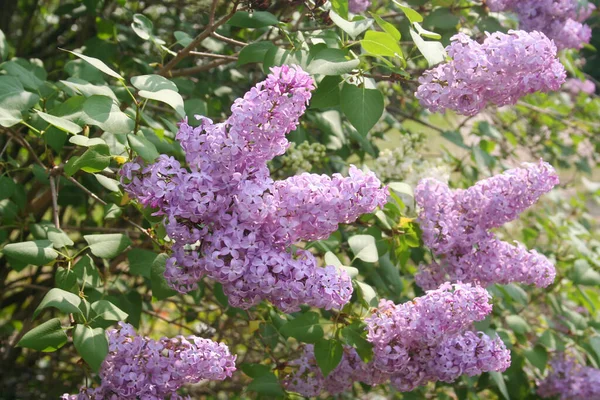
[537,354,600,400]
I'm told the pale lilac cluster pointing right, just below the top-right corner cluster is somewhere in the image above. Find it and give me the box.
[415,31,566,115]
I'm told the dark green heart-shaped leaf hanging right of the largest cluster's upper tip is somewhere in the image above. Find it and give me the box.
[340,83,384,136]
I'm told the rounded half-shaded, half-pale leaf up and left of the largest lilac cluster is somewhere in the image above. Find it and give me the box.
[83,95,135,134]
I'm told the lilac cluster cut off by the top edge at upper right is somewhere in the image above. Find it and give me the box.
[487,0,596,50]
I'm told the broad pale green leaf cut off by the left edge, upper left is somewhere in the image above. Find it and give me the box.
[0,76,40,128]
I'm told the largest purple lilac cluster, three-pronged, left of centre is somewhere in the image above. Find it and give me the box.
[121,66,387,312]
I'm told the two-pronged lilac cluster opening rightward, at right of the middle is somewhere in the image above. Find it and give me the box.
[415,160,558,289]
